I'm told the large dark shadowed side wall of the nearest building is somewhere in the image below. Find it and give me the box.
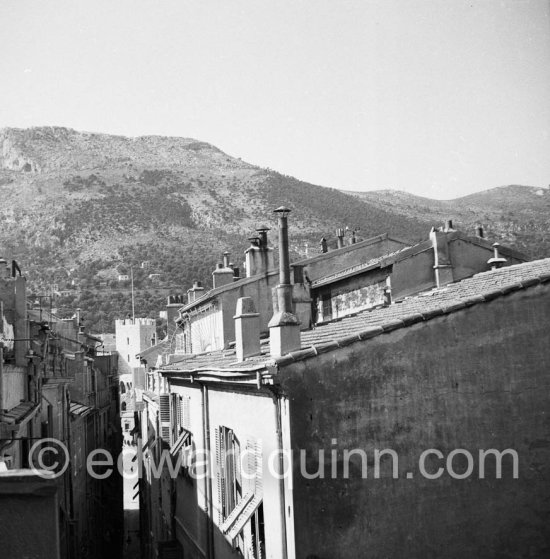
[280,284,550,559]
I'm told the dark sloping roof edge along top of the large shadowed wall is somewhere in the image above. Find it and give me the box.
[275,274,550,366]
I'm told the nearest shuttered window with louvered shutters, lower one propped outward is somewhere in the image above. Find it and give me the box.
[215,426,266,559]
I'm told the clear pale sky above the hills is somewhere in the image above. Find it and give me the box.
[0,0,550,199]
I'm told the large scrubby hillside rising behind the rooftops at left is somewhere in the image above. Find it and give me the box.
[0,127,429,331]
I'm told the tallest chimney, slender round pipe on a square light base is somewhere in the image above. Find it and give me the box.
[268,206,300,357]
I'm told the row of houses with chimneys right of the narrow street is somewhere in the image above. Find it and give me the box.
[136,208,550,559]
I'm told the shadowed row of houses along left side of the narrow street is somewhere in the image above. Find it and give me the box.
[0,260,123,559]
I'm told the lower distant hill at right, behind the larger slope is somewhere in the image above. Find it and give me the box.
[348,185,550,258]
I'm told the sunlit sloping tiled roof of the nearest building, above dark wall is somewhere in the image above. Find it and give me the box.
[158,258,550,376]
